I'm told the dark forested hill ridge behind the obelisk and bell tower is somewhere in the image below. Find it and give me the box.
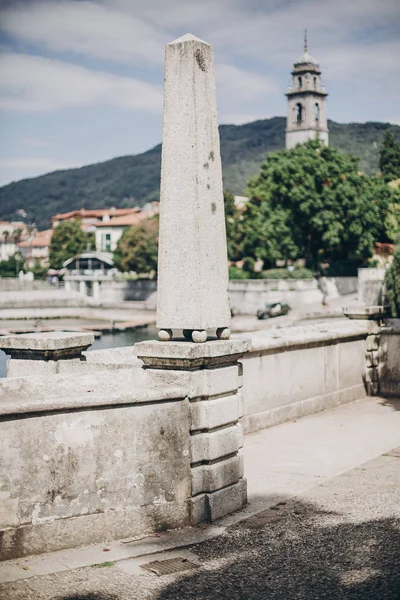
[0,117,400,229]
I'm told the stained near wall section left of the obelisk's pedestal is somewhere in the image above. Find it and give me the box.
[0,368,191,560]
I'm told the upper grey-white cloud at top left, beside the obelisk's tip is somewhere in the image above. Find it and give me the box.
[1,0,168,65]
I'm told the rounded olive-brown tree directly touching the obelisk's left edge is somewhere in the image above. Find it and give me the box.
[114,215,159,273]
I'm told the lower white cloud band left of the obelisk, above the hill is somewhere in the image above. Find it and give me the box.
[0,53,162,112]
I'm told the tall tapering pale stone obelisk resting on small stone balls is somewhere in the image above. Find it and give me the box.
[157,34,230,342]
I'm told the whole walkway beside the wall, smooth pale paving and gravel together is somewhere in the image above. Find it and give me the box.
[0,398,400,600]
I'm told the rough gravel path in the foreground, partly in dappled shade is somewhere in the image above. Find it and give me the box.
[0,449,400,600]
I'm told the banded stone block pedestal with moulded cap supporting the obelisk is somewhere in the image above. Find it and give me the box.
[135,339,249,524]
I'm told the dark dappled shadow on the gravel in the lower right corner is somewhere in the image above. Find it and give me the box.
[157,497,400,600]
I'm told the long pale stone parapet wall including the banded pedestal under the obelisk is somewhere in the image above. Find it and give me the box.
[0,321,394,559]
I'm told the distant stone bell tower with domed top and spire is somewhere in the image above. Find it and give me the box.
[286,31,329,148]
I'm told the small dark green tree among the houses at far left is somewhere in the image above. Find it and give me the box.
[49,219,94,269]
